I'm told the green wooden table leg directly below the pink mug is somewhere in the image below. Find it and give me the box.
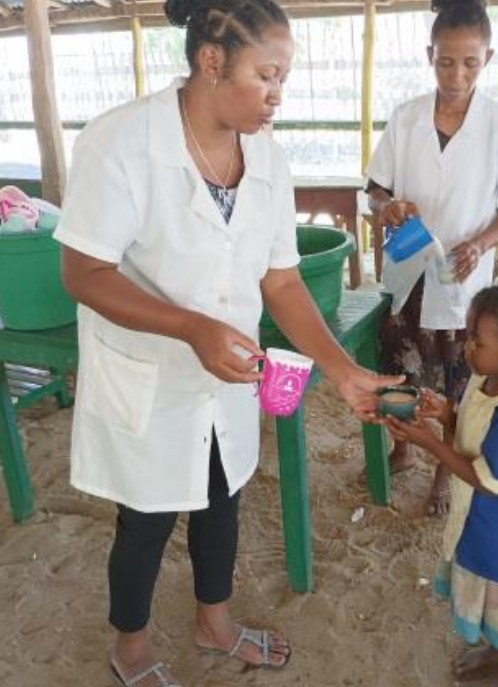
[277,403,313,592]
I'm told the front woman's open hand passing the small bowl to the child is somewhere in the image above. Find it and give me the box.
[332,364,405,422]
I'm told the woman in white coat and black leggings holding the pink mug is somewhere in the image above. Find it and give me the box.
[56,0,401,687]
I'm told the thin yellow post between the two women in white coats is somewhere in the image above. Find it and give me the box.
[361,0,375,250]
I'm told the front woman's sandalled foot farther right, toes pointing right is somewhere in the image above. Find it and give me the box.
[195,602,291,668]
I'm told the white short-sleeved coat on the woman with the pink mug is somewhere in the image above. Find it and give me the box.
[56,79,299,512]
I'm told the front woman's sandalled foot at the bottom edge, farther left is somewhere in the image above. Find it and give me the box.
[111,630,181,687]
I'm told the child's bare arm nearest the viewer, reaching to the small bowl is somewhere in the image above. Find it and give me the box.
[387,413,498,496]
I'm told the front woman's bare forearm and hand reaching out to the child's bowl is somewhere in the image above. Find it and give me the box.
[262,268,403,420]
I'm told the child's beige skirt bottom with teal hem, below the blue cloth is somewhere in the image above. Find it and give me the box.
[434,560,498,649]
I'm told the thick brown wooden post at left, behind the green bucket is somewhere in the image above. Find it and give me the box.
[24,0,66,205]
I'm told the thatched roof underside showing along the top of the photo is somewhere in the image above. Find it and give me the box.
[0,0,498,35]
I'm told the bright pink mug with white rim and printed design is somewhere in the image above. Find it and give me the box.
[259,348,313,417]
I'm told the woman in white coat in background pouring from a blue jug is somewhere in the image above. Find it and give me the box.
[367,0,498,513]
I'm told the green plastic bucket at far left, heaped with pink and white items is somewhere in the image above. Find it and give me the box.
[0,230,76,330]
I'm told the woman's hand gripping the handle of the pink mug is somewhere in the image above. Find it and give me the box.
[184,313,264,384]
